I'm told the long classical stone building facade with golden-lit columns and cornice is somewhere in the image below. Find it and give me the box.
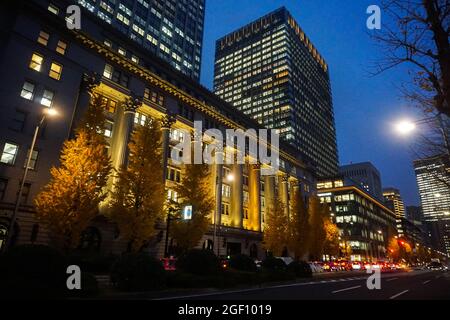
[0,0,315,257]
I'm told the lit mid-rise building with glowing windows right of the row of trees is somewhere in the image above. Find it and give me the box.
[317,177,397,261]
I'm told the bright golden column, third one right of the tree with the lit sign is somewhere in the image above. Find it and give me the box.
[249,163,262,231]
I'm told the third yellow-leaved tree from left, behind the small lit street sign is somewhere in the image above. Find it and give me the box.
[171,164,215,253]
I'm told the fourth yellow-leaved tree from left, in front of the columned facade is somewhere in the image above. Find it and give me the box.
[263,198,288,257]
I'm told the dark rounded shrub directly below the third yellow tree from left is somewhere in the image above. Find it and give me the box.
[176,249,221,275]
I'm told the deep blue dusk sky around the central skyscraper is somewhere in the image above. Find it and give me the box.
[201,0,422,205]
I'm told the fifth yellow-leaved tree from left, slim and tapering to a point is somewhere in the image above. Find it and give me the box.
[287,190,311,259]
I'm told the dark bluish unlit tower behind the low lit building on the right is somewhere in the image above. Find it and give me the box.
[339,162,384,201]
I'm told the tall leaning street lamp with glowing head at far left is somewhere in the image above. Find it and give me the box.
[4,108,58,250]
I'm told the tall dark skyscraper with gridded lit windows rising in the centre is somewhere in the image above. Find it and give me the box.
[214,7,338,176]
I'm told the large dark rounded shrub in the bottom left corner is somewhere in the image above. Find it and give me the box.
[0,245,68,299]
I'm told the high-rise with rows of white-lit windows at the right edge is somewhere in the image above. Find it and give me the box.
[414,156,450,254]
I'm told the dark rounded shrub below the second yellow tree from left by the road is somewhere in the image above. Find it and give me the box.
[111,253,165,291]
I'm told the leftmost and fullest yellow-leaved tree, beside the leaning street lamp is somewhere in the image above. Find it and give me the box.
[35,96,112,250]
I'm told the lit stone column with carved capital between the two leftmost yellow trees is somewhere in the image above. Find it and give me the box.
[116,96,142,169]
